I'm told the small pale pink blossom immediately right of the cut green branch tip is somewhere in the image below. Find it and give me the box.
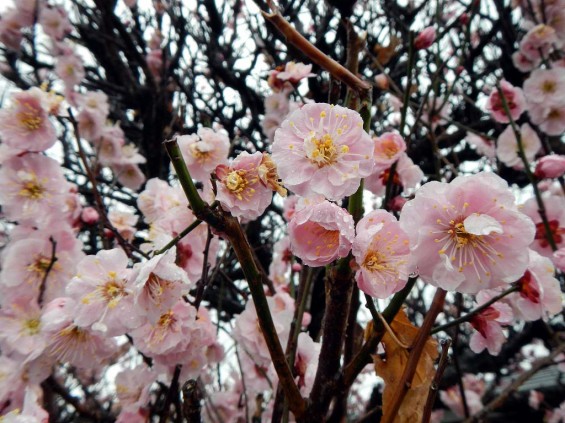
[177,128,230,181]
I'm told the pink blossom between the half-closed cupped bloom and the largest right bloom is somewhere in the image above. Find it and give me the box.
[352,210,410,298]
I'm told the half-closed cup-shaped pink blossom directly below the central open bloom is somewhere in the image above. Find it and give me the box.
[288,201,355,267]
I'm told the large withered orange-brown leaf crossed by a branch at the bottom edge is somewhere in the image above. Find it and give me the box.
[373,310,438,423]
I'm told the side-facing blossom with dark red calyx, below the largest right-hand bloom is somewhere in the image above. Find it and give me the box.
[469,290,514,355]
